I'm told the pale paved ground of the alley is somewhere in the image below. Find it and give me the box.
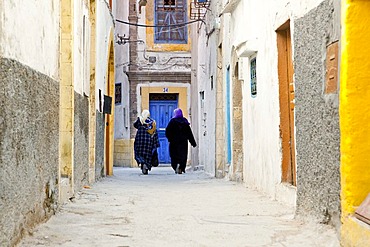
[19,167,339,247]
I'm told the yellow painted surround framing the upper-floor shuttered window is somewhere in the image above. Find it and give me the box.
[145,0,191,52]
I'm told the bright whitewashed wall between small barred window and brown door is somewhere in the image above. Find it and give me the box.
[224,0,321,205]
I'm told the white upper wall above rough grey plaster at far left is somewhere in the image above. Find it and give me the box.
[0,0,60,80]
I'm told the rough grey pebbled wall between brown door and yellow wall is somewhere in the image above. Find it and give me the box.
[294,0,340,227]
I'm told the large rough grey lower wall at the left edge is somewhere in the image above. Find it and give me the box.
[0,58,59,246]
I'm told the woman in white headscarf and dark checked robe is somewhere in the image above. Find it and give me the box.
[134,110,159,175]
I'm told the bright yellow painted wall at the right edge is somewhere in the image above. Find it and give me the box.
[340,0,370,246]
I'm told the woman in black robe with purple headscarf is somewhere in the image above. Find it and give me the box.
[166,108,197,174]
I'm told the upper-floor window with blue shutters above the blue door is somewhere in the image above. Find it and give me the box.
[154,0,188,44]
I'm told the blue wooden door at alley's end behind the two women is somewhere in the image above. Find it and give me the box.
[149,100,177,163]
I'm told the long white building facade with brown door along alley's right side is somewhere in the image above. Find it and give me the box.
[192,0,339,217]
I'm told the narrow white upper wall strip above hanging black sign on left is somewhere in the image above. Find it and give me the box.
[91,0,114,109]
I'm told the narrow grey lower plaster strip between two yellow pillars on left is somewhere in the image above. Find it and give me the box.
[73,92,89,191]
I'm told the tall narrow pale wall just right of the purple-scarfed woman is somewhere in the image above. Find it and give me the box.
[192,15,218,176]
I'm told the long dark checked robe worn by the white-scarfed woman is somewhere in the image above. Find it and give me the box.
[134,118,159,170]
